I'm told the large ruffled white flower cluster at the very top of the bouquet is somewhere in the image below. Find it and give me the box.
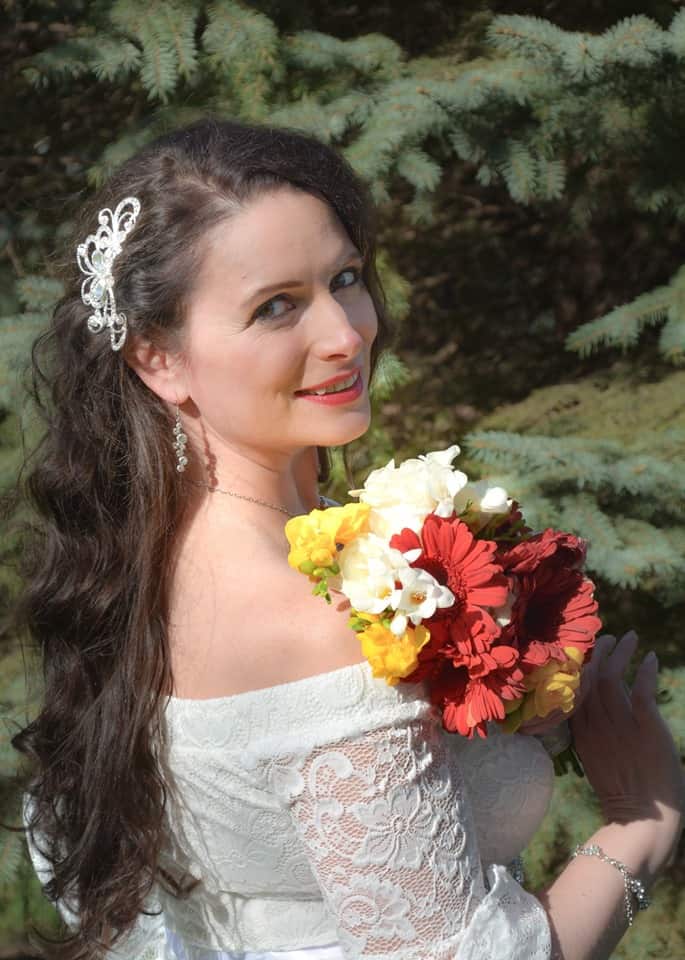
[349,444,468,540]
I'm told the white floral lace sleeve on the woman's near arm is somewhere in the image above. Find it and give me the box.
[264,714,551,960]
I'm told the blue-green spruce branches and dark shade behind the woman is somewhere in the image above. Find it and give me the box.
[0,0,685,958]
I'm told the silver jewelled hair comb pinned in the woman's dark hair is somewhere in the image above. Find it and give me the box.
[76,197,140,350]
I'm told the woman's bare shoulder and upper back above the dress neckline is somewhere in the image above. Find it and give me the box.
[169,516,363,698]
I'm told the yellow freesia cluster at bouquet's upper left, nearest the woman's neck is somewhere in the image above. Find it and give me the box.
[285,503,371,580]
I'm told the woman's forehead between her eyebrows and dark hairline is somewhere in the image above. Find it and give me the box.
[203,187,351,287]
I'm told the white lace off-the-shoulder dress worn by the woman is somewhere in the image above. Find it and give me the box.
[31,661,554,960]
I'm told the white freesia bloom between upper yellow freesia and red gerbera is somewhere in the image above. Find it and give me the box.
[337,533,408,613]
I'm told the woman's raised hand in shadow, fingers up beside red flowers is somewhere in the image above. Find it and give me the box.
[571,631,685,873]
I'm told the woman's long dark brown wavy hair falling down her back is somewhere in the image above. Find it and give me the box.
[13,118,389,960]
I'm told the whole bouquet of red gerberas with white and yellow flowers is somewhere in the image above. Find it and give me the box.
[285,444,601,738]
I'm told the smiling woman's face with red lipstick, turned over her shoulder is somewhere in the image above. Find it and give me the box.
[176,188,377,464]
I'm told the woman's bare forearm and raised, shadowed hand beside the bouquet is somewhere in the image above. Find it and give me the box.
[539,633,685,960]
